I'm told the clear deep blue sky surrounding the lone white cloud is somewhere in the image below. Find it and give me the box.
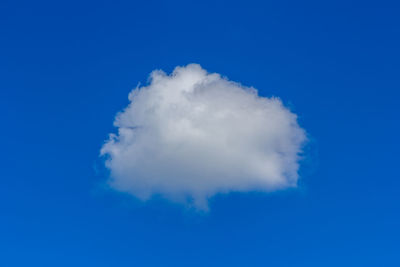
[0,1,400,267]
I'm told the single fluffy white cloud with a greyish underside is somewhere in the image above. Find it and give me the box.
[101,64,306,209]
